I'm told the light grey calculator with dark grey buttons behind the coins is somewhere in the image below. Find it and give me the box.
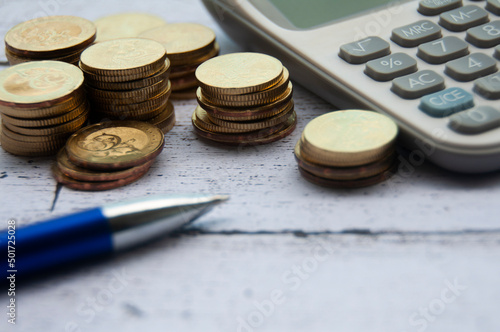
[203,0,500,173]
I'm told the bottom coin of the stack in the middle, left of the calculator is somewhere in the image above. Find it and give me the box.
[192,112,297,146]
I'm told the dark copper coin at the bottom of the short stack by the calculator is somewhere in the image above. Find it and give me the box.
[299,160,398,189]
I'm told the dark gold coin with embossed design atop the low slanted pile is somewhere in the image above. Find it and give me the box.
[66,121,164,170]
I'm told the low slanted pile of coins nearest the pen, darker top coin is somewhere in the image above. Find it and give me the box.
[52,121,164,191]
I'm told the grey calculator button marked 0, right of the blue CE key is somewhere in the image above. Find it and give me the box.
[449,106,500,134]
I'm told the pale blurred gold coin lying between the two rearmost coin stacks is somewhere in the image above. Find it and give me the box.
[94,13,167,43]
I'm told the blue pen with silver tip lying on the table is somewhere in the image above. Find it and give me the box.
[0,195,229,281]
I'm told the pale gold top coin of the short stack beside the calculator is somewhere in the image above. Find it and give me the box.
[301,110,398,167]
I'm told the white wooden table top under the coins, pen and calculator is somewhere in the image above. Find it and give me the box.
[0,0,500,332]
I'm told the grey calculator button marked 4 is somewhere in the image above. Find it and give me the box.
[444,53,497,82]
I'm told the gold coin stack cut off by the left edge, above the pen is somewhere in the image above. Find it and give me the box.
[0,61,89,157]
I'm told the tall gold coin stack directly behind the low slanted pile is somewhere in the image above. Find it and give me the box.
[80,38,175,133]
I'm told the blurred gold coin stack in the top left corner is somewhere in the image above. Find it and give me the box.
[5,16,96,65]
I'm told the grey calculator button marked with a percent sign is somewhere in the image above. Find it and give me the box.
[365,53,417,81]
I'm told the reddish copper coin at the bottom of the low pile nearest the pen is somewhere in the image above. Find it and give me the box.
[52,165,149,191]
